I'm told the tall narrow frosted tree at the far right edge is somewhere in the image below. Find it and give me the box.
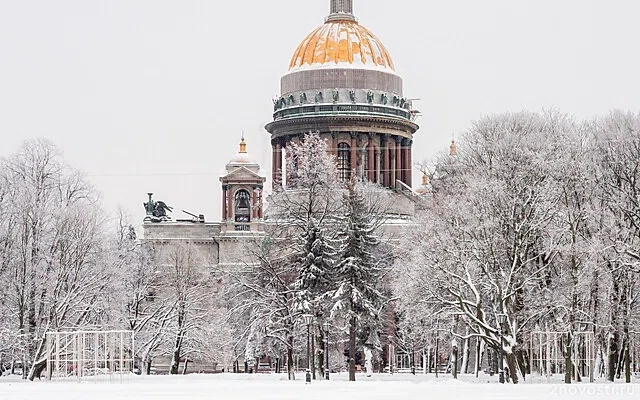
[588,111,640,382]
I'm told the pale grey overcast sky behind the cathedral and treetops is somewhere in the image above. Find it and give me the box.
[0,0,640,222]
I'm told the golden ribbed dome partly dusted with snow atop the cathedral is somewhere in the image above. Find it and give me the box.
[289,19,394,71]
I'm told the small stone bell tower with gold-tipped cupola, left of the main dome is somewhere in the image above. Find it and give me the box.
[220,135,266,232]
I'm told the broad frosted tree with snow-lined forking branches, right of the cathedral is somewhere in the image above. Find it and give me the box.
[395,113,572,382]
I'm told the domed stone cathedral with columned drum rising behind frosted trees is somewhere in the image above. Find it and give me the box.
[143,0,428,268]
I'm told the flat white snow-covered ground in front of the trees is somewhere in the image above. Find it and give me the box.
[0,374,640,400]
